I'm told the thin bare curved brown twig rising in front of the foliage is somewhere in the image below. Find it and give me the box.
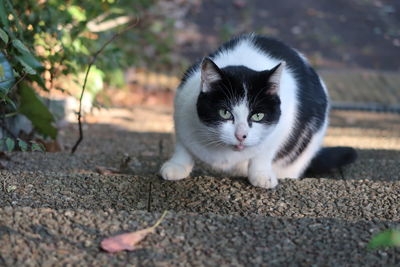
[71,21,138,154]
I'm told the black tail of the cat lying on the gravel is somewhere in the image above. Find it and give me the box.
[306,146,357,175]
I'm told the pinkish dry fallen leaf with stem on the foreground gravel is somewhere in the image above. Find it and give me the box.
[100,211,168,252]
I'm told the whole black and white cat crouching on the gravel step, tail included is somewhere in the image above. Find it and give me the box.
[160,34,356,188]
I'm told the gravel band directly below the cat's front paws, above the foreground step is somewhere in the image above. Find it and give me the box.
[0,172,400,221]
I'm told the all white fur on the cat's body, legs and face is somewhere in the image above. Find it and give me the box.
[161,36,327,188]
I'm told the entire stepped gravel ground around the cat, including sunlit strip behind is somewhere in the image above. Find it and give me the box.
[0,107,400,266]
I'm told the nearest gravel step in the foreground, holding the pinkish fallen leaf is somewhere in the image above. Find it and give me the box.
[0,210,400,266]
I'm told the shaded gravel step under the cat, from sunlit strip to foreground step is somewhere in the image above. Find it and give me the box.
[0,120,400,221]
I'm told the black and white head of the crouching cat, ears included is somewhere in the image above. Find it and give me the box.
[197,58,285,150]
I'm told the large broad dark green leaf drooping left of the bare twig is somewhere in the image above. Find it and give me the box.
[19,83,57,139]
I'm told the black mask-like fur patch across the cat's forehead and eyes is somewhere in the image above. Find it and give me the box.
[197,66,280,127]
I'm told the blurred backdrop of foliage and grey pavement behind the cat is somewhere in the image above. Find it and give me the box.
[0,0,400,150]
